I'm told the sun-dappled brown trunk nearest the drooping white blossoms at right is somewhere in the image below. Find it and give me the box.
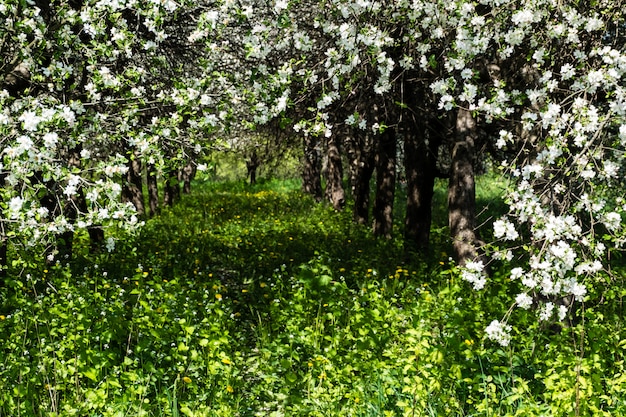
[448,108,477,265]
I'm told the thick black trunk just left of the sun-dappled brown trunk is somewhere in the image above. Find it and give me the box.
[404,131,439,253]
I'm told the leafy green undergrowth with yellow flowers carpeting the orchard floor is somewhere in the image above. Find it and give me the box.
[0,178,626,417]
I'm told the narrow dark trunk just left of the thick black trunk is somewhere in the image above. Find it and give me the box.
[373,128,397,238]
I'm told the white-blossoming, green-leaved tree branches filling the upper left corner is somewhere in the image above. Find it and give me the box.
[0,1,232,264]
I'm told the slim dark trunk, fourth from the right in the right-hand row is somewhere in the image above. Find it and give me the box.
[346,132,374,224]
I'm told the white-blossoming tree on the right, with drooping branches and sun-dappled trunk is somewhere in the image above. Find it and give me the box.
[208,0,626,344]
